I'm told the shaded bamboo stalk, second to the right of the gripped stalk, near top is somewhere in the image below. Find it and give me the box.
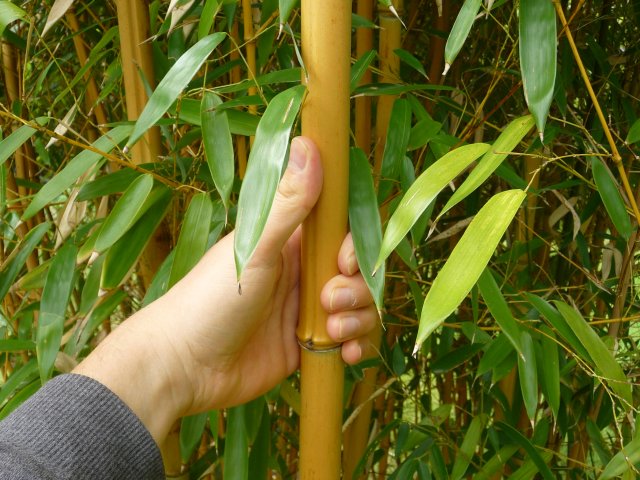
[374,1,403,180]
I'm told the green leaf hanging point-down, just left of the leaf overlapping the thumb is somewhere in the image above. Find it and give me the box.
[201,92,235,216]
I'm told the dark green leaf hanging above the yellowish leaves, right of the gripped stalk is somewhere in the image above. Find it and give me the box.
[378,98,411,203]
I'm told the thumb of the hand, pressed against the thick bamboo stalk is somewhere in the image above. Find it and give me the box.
[254,137,322,263]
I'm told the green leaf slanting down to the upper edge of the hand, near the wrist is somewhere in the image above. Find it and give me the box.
[169,193,213,288]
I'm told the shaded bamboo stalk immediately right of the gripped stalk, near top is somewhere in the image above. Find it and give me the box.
[356,0,373,156]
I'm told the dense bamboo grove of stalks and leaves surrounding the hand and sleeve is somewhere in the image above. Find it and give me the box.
[0,0,640,480]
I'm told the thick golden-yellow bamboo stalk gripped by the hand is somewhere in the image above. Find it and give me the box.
[298,0,351,480]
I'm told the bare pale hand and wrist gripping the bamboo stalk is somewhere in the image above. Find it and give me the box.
[74,137,379,444]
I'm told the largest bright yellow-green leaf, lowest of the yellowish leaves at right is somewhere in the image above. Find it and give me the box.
[414,190,526,354]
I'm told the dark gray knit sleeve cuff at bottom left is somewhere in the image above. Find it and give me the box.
[0,374,165,480]
